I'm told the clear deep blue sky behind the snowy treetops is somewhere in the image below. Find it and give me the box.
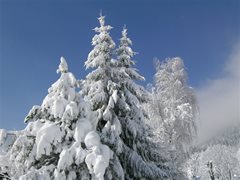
[0,0,240,130]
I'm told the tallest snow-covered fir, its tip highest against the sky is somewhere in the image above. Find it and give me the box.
[81,15,124,179]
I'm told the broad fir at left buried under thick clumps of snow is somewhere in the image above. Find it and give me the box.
[0,57,110,179]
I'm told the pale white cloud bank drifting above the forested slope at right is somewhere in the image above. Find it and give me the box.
[197,43,240,142]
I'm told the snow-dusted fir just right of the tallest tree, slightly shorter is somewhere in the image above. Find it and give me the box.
[116,27,167,179]
